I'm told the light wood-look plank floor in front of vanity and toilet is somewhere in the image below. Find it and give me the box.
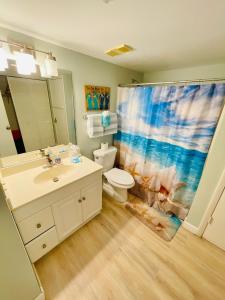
[36,198,225,300]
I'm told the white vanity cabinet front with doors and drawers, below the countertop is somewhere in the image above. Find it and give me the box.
[13,170,102,262]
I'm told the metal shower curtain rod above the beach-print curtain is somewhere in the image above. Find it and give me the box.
[119,78,225,87]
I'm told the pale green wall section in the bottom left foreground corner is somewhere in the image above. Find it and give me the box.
[0,185,41,300]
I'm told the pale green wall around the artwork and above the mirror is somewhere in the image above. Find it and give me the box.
[0,28,143,157]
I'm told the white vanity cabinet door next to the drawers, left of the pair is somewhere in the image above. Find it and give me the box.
[53,192,83,240]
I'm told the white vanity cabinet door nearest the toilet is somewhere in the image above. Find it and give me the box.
[81,181,102,221]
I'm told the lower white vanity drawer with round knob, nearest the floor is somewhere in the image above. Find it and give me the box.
[26,227,58,262]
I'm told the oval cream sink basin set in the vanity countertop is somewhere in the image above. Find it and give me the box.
[34,165,74,184]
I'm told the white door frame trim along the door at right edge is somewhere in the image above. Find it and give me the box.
[197,168,225,237]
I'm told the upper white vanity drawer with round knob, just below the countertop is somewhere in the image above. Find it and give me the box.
[18,207,54,244]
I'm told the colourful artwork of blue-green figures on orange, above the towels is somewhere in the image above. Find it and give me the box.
[84,85,110,111]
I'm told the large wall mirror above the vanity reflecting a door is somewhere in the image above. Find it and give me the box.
[0,70,76,158]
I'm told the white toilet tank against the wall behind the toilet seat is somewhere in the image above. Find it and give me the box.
[93,147,117,173]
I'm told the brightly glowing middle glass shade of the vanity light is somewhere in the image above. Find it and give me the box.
[15,52,36,75]
